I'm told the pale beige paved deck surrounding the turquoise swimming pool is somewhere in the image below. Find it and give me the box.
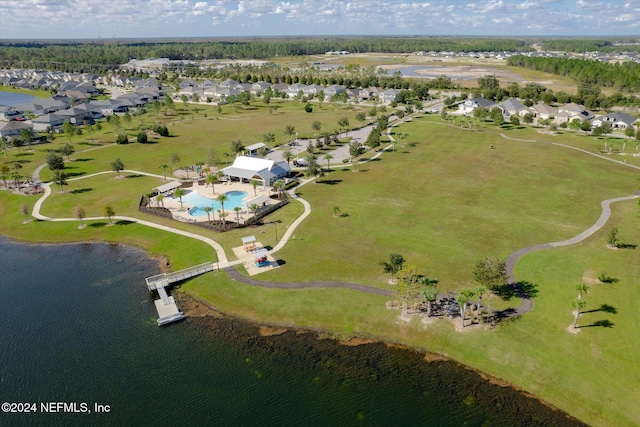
[151,182,276,222]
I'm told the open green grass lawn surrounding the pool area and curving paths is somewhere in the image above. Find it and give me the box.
[0,104,640,426]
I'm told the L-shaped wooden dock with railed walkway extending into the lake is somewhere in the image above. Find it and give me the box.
[145,262,213,326]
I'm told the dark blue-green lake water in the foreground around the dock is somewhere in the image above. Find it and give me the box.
[0,238,579,426]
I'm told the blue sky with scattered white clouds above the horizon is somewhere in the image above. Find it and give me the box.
[0,0,640,40]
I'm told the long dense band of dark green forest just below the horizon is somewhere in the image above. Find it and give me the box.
[0,37,532,72]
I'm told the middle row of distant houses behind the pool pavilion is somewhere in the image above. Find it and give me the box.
[175,79,400,103]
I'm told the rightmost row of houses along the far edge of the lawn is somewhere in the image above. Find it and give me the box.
[458,98,638,129]
